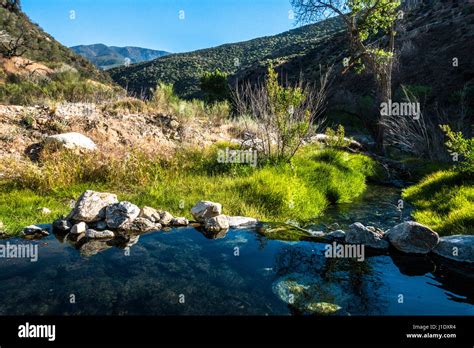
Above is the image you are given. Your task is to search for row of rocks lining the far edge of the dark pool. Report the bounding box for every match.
[12,190,474,264]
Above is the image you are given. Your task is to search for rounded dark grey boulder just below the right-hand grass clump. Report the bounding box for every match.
[386,221,439,254]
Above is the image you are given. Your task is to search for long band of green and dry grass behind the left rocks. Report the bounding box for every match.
[0,143,375,234]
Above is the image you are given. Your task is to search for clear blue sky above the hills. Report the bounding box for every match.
[22,0,295,52]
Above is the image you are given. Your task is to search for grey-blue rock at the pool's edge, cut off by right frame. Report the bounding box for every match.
[433,235,474,263]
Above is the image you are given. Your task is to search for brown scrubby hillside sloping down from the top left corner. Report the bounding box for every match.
[0,2,111,83]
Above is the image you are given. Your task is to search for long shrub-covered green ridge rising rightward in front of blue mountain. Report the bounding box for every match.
[108,18,342,98]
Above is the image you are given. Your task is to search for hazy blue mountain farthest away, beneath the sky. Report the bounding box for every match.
[71,44,170,70]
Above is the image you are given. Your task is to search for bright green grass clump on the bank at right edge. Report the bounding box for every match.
[403,170,474,235]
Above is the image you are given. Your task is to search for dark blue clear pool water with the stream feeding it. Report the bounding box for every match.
[0,188,474,315]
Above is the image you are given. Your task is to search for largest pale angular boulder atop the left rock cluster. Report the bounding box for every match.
[68,190,118,222]
